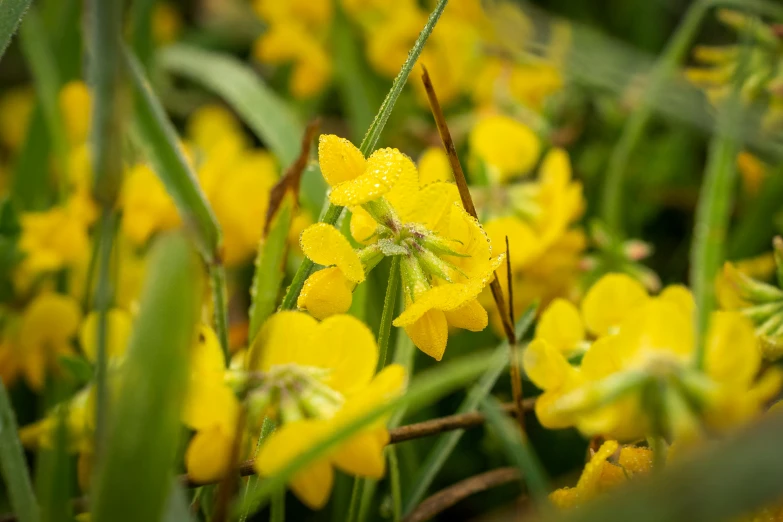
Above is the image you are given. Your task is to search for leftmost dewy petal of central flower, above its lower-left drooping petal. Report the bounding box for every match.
[299,223,364,283]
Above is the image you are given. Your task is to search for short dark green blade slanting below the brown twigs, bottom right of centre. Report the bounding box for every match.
[481,397,550,502]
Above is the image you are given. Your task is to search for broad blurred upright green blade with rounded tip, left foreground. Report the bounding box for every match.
[91,234,203,522]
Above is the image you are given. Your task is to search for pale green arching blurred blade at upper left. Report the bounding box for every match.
[158,44,304,165]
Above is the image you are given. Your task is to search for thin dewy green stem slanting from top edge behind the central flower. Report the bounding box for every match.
[280,0,448,310]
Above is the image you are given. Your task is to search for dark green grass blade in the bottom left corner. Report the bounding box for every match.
[0,380,41,522]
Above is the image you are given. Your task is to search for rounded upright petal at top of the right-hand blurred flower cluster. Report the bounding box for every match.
[582,274,648,335]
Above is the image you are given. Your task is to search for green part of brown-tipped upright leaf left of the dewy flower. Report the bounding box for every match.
[248,196,296,342]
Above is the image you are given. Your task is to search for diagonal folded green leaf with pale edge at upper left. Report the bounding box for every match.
[125,45,220,264]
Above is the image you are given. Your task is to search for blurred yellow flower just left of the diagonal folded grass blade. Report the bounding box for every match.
[121,164,180,246]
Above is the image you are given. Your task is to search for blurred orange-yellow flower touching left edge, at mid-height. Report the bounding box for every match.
[0,293,81,391]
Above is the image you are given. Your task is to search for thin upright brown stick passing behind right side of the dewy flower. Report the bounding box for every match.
[421,65,525,433]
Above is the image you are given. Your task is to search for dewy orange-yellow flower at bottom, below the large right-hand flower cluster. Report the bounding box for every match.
[549,440,652,509]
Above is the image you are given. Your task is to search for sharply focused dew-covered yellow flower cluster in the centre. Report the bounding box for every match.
[298,135,502,360]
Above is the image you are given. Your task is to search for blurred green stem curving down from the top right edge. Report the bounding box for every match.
[602,0,710,234]
